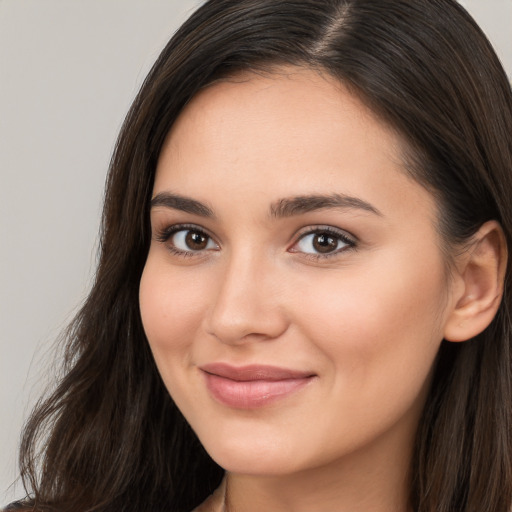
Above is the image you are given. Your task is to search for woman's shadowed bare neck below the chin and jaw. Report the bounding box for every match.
[225,424,413,512]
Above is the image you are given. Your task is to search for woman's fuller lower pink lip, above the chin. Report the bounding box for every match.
[204,373,313,409]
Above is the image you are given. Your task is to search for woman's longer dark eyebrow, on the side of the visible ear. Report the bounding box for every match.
[270,194,383,218]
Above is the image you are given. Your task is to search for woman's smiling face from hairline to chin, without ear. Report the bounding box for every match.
[140,69,450,475]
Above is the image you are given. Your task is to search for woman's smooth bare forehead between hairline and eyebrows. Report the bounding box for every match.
[155,68,433,224]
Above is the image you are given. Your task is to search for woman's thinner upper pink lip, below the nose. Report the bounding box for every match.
[200,363,315,381]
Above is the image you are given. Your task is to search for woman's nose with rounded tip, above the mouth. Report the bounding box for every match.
[205,253,288,345]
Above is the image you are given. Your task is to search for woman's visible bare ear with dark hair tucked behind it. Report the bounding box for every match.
[444,221,507,341]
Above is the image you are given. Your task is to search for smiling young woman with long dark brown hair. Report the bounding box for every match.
[7,0,512,512]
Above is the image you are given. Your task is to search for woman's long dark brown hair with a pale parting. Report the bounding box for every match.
[13,0,512,512]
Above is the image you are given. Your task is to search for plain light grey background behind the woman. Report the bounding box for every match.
[0,0,512,506]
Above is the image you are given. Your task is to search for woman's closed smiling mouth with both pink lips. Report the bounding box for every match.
[200,363,316,409]
